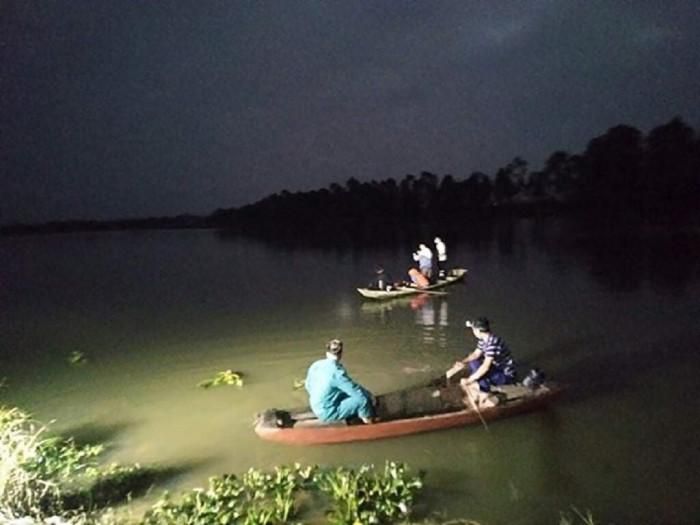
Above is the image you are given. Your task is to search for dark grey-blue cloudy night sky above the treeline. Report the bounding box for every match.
[0,0,700,224]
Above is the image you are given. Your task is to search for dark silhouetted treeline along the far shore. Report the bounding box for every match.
[0,117,700,239]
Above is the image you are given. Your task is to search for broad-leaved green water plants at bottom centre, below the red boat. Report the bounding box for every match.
[143,462,422,525]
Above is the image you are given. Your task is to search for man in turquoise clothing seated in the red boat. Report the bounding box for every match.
[305,339,375,423]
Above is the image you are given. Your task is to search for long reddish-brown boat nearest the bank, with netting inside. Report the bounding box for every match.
[255,374,561,445]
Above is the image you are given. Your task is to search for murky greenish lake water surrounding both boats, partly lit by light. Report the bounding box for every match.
[0,222,700,524]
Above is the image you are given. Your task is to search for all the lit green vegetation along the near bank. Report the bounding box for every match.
[0,406,595,525]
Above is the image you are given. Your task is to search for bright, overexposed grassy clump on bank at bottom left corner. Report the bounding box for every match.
[0,407,167,524]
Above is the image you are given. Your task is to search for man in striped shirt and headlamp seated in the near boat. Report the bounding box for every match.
[446,317,515,395]
